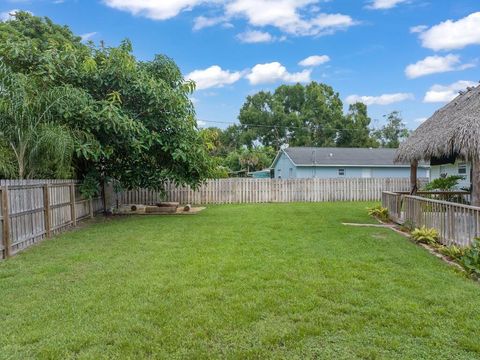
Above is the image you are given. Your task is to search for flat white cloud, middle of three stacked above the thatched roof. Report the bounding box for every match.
[405,54,475,79]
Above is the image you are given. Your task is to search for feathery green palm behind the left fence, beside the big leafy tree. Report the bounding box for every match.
[0,61,75,179]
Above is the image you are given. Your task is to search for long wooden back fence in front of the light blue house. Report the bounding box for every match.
[116,178,420,205]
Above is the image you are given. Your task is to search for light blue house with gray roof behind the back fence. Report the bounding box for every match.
[272,147,430,179]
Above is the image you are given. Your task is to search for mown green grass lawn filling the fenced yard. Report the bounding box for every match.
[0,203,480,359]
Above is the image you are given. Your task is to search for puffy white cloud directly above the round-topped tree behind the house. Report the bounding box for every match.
[246,62,311,85]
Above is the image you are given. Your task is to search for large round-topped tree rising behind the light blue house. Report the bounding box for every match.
[239,82,376,150]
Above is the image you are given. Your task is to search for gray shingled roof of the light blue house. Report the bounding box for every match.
[273,147,425,167]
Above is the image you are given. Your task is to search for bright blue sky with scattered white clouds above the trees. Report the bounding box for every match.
[0,0,480,129]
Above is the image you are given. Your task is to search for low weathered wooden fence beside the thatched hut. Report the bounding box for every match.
[382,192,480,247]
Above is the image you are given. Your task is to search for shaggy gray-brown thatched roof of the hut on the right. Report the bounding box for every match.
[395,86,480,162]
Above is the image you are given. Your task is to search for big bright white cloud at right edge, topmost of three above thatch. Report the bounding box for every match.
[420,12,480,51]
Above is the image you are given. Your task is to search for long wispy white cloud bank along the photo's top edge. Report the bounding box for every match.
[104,0,356,36]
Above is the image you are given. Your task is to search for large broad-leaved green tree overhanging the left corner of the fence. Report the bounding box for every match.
[0,12,212,188]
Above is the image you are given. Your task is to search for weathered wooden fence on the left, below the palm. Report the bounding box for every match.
[0,180,103,259]
